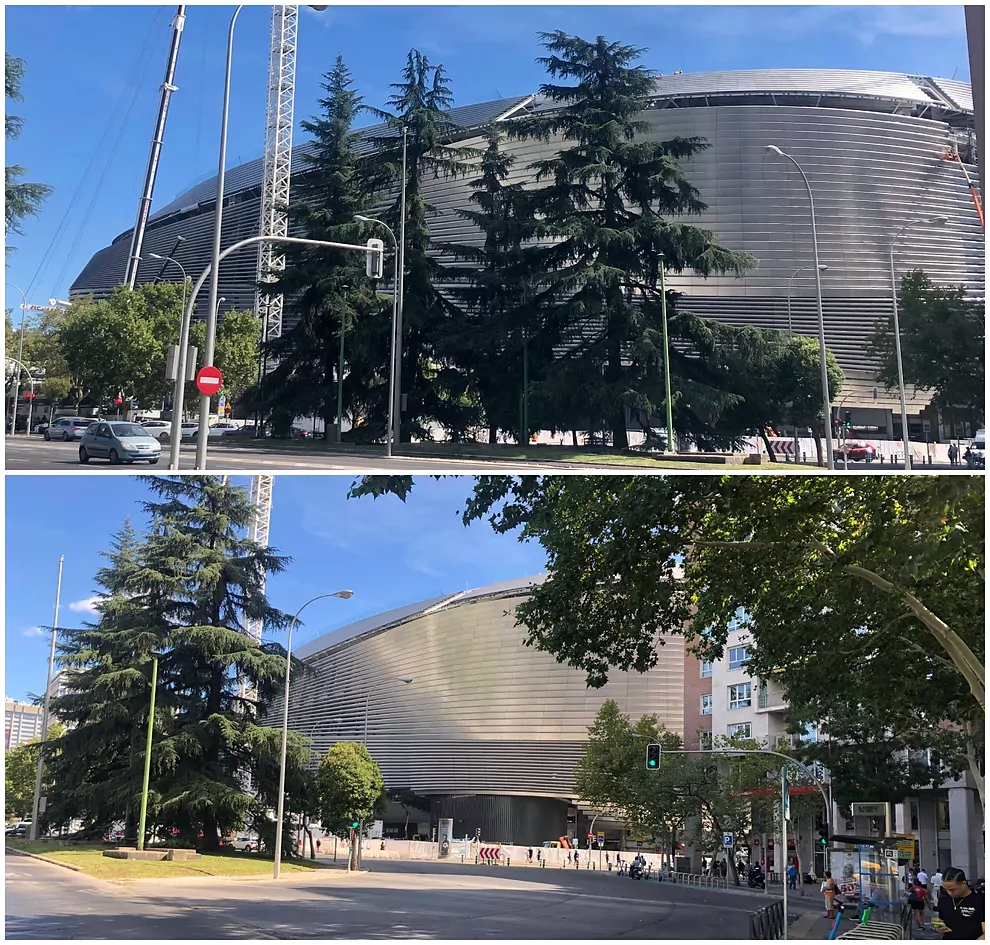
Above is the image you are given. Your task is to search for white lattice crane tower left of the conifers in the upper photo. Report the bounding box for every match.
[255,5,299,350]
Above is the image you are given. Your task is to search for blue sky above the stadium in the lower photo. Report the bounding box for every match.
[5,476,546,699]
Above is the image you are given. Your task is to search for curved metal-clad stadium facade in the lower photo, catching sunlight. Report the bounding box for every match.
[269,589,684,797]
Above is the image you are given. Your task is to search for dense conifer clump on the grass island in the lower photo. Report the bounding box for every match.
[49,476,308,850]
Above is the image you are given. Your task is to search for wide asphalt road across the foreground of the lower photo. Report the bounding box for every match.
[6,857,821,940]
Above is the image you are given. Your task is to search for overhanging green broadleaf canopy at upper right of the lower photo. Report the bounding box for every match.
[353,476,985,800]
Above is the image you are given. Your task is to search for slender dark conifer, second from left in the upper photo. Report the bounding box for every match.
[360,49,479,441]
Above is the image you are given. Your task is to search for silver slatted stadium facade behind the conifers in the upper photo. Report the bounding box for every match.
[71,69,985,438]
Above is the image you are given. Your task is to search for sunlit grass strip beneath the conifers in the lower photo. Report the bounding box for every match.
[6,840,322,880]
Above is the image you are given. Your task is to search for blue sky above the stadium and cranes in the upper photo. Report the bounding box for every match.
[4,5,969,308]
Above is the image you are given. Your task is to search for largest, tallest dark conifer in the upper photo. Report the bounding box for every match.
[510,31,750,448]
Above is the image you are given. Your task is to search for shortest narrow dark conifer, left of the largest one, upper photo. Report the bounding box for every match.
[440,123,553,443]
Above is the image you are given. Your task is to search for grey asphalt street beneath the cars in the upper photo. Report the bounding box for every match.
[5,436,564,474]
